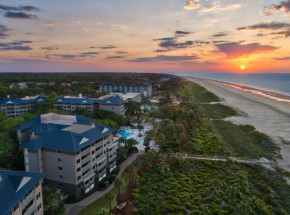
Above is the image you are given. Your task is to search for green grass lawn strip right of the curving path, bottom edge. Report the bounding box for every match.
[80,171,129,215]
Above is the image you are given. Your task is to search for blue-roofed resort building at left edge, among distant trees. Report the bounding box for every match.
[0,96,47,117]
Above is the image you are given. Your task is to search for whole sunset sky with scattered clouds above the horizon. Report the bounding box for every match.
[0,0,290,73]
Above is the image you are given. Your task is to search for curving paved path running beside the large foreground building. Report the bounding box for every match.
[64,151,144,215]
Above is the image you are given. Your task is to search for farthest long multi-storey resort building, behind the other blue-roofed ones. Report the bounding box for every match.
[99,82,152,97]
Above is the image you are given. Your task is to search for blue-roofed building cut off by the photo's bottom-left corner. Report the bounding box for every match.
[0,170,43,215]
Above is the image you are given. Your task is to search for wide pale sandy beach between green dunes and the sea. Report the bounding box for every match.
[185,77,290,172]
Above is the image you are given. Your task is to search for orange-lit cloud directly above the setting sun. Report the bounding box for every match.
[215,42,278,58]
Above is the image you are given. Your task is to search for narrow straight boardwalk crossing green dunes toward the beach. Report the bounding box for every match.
[169,153,275,167]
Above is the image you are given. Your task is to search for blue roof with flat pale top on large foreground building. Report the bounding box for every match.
[15,113,115,153]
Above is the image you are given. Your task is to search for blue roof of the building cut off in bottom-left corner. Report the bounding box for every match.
[0,170,44,214]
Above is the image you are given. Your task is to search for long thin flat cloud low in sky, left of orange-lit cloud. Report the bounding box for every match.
[128,55,199,63]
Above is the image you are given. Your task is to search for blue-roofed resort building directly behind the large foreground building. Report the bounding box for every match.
[54,94,125,115]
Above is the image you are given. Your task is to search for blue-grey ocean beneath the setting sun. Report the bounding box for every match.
[176,73,290,96]
